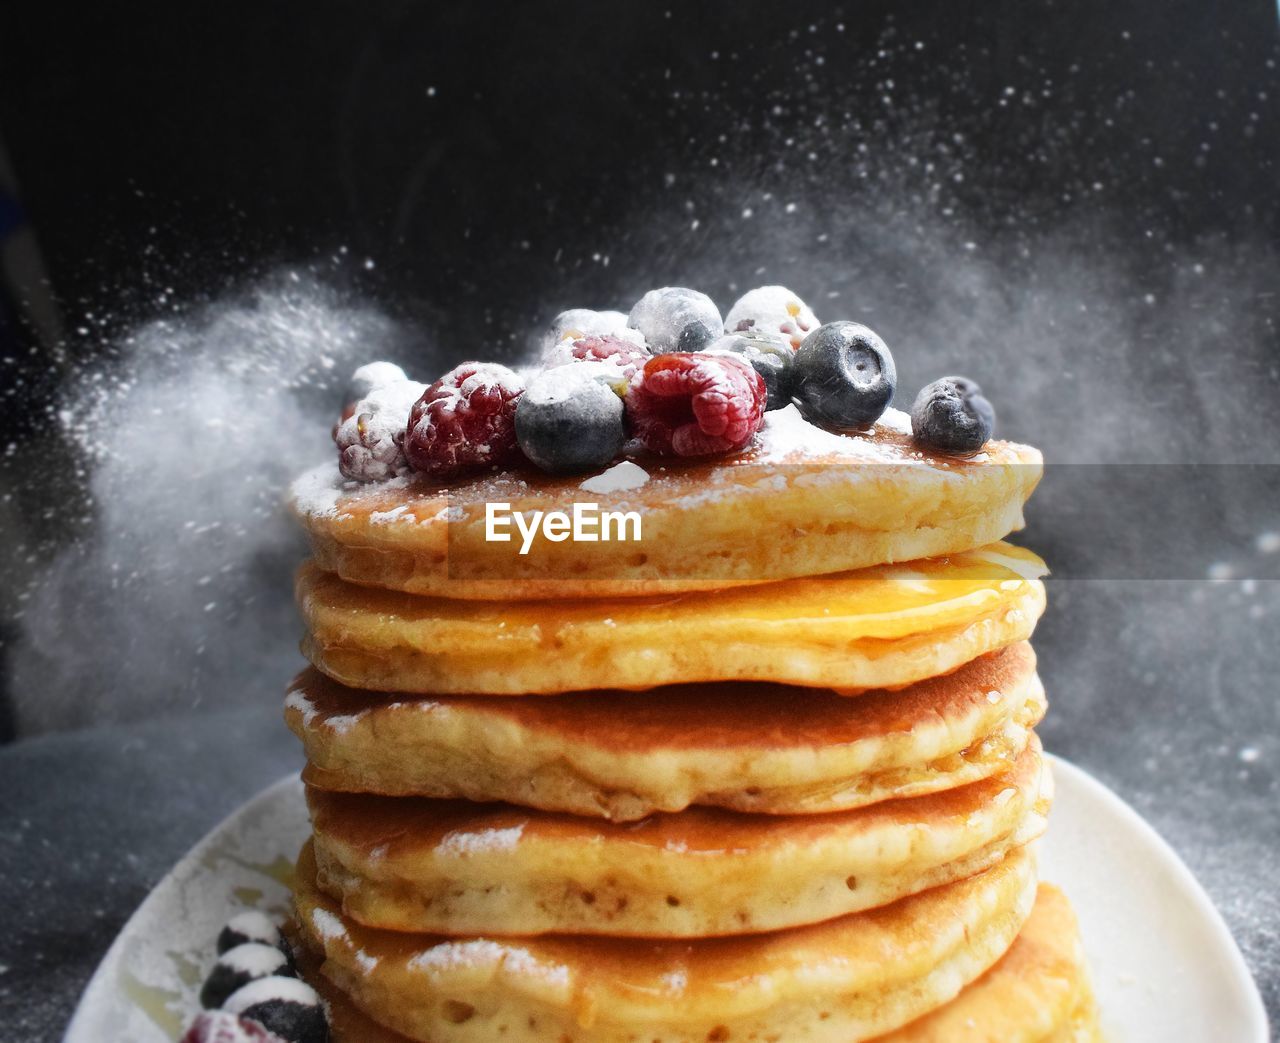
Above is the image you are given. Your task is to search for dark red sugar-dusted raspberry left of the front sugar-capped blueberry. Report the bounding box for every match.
[404,362,525,480]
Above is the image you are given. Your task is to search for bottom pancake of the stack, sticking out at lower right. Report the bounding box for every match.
[293,884,1102,1043]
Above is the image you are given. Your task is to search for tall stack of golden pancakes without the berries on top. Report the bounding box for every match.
[287,410,1097,1043]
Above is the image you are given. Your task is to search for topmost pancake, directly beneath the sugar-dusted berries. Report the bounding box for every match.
[292,407,1043,600]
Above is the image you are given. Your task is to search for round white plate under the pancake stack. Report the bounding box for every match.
[64,758,1268,1043]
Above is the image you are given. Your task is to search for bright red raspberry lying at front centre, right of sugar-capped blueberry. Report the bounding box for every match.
[625,352,768,457]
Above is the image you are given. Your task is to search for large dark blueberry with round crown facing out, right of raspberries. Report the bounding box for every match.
[791,321,897,430]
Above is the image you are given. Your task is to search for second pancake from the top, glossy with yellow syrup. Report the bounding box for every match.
[297,544,1044,695]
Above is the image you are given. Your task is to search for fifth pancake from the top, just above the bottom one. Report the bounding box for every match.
[296,847,1036,1043]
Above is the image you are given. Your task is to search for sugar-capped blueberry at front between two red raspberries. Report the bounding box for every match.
[516,360,624,475]
